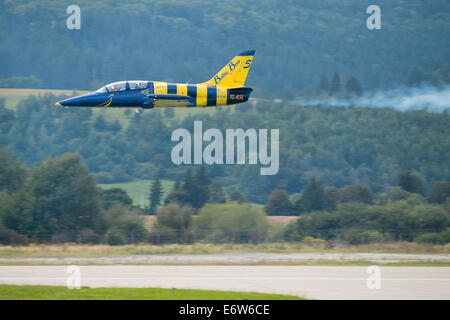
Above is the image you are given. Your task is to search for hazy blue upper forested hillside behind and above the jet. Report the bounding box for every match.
[0,0,450,96]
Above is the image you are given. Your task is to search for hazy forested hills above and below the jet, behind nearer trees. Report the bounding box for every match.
[0,0,450,203]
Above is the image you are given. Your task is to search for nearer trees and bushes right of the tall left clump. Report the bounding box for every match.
[146,167,450,244]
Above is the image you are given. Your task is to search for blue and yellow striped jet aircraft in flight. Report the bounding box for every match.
[56,50,255,109]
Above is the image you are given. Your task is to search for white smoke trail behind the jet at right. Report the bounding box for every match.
[294,85,450,112]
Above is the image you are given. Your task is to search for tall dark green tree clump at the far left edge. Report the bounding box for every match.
[0,148,148,244]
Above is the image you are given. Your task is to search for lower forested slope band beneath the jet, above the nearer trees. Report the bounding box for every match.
[0,95,450,203]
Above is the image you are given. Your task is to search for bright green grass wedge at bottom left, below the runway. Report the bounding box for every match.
[0,285,303,300]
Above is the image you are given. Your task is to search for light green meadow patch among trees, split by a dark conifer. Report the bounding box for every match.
[100,180,174,207]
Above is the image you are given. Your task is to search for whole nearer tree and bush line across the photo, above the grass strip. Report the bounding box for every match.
[0,148,450,245]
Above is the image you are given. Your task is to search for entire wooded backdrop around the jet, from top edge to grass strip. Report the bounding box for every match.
[0,0,450,248]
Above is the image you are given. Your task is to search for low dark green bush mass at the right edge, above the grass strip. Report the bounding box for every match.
[285,198,450,243]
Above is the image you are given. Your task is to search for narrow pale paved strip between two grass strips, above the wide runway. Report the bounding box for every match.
[0,252,450,266]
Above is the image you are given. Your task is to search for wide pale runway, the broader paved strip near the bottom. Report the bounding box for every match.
[0,265,450,300]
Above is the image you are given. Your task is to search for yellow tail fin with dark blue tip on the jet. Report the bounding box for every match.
[200,50,255,88]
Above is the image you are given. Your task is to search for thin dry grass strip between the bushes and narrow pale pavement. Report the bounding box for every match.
[0,242,450,263]
